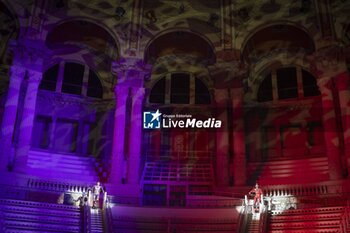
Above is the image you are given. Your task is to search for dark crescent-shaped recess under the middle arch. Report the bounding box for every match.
[144,28,216,64]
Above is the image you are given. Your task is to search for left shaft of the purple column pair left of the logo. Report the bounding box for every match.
[109,86,129,186]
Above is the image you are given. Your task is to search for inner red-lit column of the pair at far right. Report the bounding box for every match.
[318,78,342,180]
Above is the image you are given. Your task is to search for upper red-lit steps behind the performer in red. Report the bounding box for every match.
[247,157,329,185]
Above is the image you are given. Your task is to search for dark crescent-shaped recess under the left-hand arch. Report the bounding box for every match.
[45,17,120,59]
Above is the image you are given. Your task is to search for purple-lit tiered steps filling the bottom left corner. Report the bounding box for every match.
[0,199,81,233]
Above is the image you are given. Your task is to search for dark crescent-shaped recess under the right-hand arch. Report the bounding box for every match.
[241,22,315,62]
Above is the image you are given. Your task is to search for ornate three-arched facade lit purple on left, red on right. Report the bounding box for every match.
[0,0,350,232]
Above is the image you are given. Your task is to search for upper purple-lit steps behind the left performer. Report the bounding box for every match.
[27,151,99,183]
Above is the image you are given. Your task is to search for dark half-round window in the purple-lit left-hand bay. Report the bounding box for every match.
[39,62,103,98]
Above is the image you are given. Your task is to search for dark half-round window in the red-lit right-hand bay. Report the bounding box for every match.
[257,67,320,102]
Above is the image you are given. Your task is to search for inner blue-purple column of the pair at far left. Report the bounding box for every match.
[14,70,42,171]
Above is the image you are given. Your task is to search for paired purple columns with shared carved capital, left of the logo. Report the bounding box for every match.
[110,57,151,198]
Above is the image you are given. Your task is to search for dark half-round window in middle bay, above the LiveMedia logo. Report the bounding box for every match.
[149,73,210,104]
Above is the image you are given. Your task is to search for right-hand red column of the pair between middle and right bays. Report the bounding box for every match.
[231,88,247,186]
